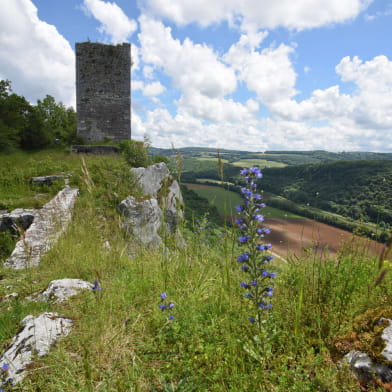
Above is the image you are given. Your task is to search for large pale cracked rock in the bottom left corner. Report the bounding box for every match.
[0,313,72,386]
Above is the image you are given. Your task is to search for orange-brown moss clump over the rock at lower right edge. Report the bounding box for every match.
[331,305,392,365]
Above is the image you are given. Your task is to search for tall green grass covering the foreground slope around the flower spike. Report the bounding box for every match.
[0,151,392,392]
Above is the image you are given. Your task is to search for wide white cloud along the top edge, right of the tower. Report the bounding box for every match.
[145,0,372,30]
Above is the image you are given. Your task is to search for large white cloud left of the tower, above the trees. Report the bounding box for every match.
[0,0,75,105]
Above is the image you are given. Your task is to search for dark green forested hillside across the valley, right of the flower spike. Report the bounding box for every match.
[263,160,392,227]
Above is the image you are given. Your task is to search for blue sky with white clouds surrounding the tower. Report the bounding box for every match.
[0,0,392,152]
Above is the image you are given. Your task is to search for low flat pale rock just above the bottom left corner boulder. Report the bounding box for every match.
[28,279,93,303]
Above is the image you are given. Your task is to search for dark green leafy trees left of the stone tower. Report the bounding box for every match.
[0,80,81,152]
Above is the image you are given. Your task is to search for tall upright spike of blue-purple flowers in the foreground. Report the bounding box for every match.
[235,167,276,324]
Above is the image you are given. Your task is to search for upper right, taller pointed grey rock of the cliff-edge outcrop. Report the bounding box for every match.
[131,162,184,234]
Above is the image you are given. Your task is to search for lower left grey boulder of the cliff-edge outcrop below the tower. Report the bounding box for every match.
[118,196,162,247]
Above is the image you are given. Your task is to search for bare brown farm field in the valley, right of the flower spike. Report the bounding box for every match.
[265,218,383,259]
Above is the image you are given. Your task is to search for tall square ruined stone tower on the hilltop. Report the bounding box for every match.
[75,42,131,142]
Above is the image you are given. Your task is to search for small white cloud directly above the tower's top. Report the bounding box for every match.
[84,0,137,44]
